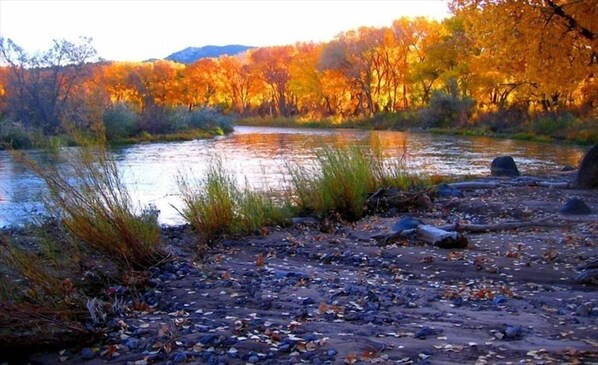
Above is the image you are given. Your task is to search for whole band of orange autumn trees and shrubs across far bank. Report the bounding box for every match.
[0,0,598,146]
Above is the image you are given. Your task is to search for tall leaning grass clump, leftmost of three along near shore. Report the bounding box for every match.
[15,144,165,270]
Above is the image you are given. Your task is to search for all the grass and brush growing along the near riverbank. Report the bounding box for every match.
[0,137,432,350]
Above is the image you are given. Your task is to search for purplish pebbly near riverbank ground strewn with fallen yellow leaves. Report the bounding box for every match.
[2,169,598,364]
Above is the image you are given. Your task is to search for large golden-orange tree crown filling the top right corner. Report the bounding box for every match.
[451,0,598,110]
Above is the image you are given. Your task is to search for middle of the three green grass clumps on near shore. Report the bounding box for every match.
[179,159,290,242]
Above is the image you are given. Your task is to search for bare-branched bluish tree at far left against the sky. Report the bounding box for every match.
[0,38,97,133]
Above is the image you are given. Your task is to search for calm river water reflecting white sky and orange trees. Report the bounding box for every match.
[0,127,584,227]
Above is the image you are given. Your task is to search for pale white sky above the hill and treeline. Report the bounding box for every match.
[0,0,449,61]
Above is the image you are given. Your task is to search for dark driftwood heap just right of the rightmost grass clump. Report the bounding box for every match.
[365,188,434,212]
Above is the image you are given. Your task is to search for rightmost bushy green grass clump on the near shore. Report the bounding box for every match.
[288,146,425,221]
